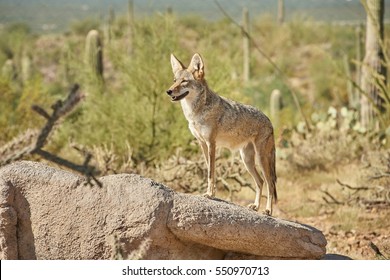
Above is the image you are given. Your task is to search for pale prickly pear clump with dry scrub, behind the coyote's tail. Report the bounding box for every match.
[279,107,378,170]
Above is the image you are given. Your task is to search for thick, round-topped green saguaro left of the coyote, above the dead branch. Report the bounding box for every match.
[85,30,103,81]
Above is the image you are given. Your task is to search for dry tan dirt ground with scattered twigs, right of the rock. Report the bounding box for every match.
[263,156,390,260]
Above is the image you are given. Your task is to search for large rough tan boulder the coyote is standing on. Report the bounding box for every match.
[0,161,326,259]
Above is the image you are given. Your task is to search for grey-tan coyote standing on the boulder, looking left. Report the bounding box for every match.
[167,53,277,215]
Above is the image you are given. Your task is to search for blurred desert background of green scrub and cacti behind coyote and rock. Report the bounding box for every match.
[0,0,390,259]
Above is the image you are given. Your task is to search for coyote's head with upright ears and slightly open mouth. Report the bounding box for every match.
[167,53,204,101]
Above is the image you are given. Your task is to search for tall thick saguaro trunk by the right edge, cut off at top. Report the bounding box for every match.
[360,0,386,128]
